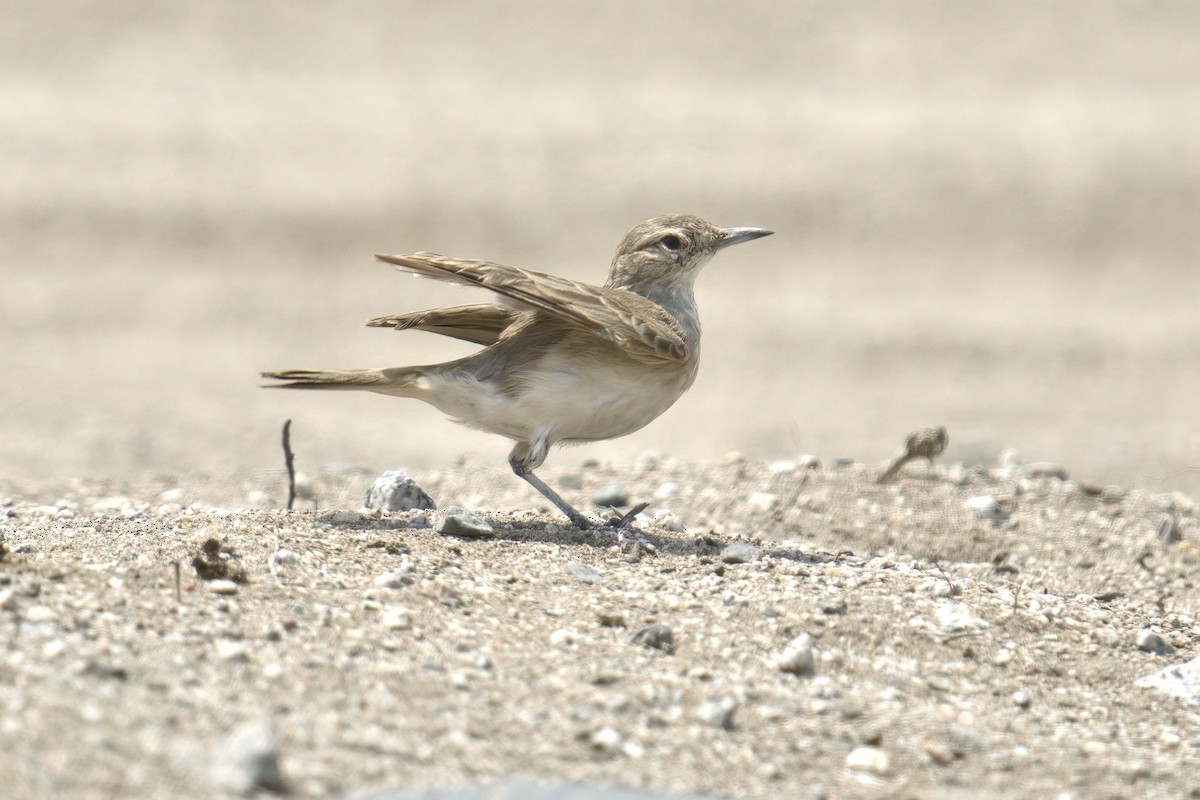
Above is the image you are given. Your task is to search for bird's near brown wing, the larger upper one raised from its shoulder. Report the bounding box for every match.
[376,253,689,363]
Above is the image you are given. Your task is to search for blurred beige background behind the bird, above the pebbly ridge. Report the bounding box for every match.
[0,0,1200,495]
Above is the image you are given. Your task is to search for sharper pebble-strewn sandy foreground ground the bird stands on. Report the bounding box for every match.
[0,458,1200,799]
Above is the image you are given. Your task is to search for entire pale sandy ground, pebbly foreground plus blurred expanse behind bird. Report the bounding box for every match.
[0,0,1200,796]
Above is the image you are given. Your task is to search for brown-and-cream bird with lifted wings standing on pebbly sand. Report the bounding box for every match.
[260,213,774,529]
